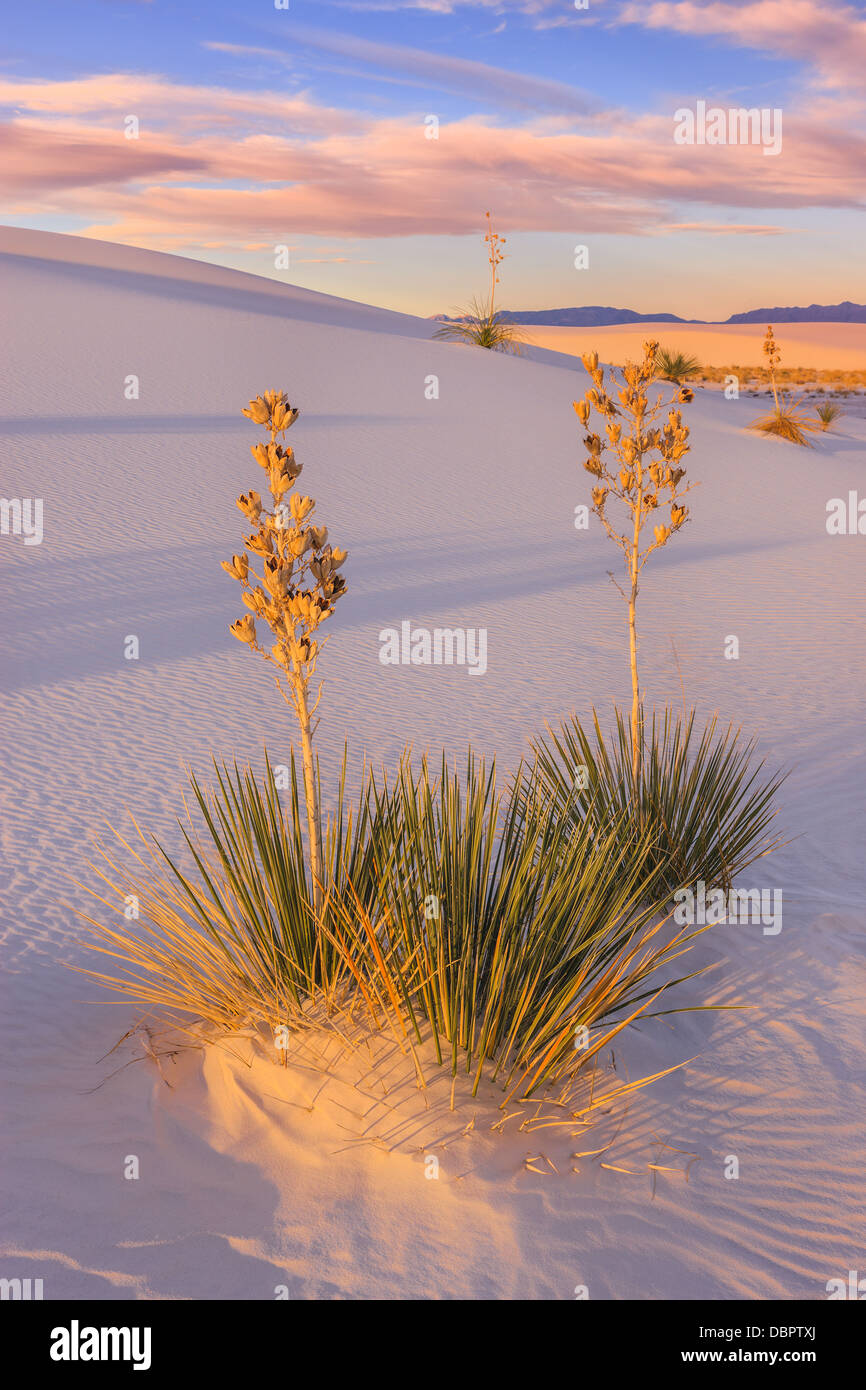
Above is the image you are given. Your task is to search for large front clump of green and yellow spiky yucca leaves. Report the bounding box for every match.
[79,755,698,1113]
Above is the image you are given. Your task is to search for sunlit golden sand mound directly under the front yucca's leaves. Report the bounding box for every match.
[166,1030,639,1182]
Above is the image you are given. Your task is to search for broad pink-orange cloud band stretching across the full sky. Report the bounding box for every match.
[0,76,866,249]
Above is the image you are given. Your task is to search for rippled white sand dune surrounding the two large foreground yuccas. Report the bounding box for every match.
[0,229,866,1300]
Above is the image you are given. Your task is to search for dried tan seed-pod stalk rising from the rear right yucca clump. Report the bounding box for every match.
[574,342,695,787]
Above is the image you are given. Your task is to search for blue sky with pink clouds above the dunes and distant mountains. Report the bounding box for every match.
[0,0,866,320]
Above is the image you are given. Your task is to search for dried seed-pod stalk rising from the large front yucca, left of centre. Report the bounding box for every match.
[222,391,346,910]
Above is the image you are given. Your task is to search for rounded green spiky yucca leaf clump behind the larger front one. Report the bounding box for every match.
[534,710,784,894]
